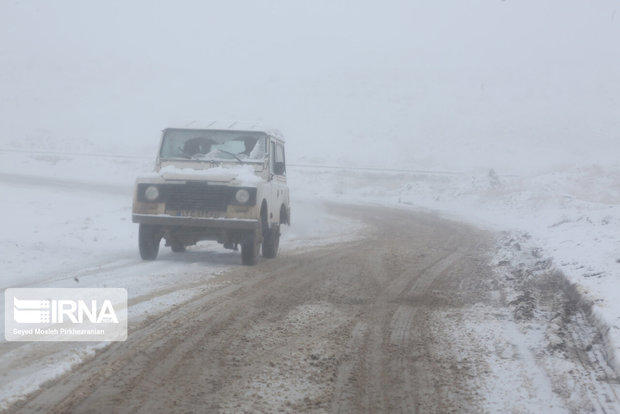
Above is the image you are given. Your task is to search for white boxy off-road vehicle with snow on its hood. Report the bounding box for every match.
[132,124,291,265]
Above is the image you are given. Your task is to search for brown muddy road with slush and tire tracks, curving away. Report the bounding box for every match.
[4,207,620,413]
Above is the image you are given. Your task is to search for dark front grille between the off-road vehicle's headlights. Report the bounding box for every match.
[166,183,228,213]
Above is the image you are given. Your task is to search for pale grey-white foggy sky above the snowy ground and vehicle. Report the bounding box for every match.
[0,0,620,171]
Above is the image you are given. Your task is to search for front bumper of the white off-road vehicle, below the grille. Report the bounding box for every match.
[132,214,259,230]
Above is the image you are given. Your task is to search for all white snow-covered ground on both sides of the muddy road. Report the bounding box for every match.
[0,148,620,409]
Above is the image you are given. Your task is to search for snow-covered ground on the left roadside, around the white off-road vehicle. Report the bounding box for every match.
[0,150,361,410]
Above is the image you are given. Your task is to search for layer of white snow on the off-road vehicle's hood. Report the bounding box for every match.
[158,165,262,185]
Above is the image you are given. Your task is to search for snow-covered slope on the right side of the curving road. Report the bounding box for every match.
[290,166,620,371]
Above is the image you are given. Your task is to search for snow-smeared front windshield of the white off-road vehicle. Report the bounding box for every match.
[160,129,266,162]
